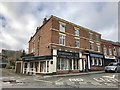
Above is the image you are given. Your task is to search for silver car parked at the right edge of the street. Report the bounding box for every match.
[105,62,120,72]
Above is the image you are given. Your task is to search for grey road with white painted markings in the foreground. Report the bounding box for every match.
[0,69,120,88]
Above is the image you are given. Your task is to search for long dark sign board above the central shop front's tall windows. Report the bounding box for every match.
[57,51,79,58]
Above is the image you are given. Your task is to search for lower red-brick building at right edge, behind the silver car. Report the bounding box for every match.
[101,39,120,66]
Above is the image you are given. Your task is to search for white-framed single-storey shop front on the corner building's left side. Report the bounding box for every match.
[23,56,52,75]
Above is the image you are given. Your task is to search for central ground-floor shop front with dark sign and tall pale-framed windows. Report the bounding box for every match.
[57,50,80,73]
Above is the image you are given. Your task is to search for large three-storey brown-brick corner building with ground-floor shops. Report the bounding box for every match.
[16,16,119,74]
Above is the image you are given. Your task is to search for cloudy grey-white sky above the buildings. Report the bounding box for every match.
[0,2,118,51]
